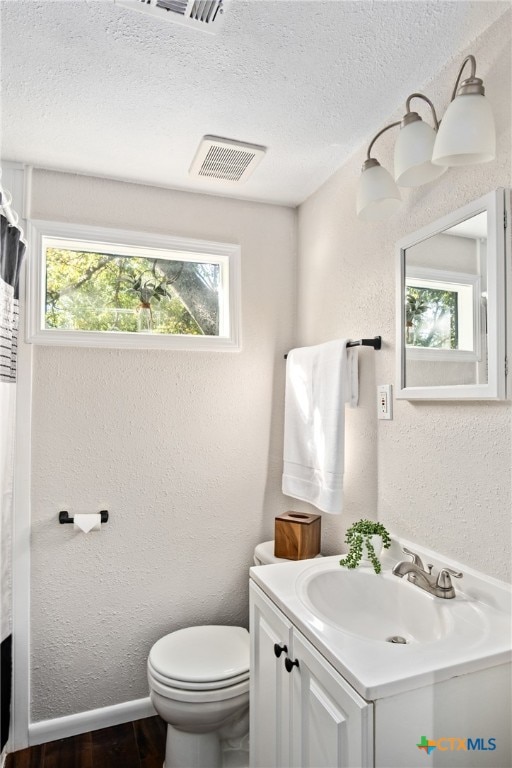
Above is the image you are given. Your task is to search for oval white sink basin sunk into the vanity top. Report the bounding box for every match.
[297,567,454,643]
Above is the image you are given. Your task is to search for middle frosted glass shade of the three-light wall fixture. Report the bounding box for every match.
[395,120,447,187]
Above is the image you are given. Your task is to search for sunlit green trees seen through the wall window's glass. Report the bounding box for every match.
[45,247,220,336]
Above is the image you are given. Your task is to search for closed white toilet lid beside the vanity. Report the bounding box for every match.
[149,626,249,683]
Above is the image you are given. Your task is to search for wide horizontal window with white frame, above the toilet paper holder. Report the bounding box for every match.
[24,221,239,350]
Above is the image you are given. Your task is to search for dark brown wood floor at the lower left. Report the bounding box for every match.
[5,717,166,768]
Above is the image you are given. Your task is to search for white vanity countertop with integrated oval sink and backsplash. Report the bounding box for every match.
[251,540,512,701]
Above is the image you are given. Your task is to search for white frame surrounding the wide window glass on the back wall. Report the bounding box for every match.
[26,219,241,352]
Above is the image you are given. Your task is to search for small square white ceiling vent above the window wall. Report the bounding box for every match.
[189,136,266,183]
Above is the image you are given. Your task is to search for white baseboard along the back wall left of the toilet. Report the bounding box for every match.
[28,696,156,747]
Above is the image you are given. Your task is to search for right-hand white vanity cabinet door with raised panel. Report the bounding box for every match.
[290,630,373,768]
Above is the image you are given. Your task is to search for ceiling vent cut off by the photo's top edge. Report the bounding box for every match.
[114,0,226,33]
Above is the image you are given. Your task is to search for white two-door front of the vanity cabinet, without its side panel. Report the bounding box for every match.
[250,584,373,768]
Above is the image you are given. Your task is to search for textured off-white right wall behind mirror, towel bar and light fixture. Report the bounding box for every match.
[298,12,512,579]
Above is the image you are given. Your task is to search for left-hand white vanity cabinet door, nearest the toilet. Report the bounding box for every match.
[250,584,292,768]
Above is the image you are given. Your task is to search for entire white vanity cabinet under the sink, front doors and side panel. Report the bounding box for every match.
[250,584,512,768]
